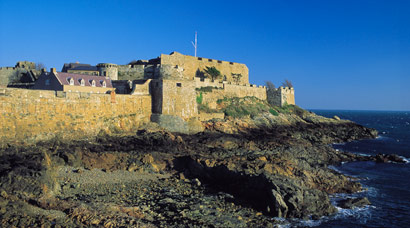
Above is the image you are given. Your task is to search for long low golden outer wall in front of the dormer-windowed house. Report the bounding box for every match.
[0,88,151,142]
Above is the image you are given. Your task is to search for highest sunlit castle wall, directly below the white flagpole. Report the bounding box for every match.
[160,52,249,84]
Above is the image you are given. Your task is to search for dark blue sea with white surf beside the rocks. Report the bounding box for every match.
[308,110,410,227]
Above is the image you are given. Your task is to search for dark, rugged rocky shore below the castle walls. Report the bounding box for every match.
[0,111,400,227]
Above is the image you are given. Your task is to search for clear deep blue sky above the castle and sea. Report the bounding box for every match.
[0,0,410,110]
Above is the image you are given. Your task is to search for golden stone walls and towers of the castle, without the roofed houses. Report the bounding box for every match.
[0,52,295,141]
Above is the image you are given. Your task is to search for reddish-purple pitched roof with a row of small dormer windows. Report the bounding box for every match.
[51,72,112,88]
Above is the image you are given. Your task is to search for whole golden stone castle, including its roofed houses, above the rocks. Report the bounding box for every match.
[0,52,295,138]
